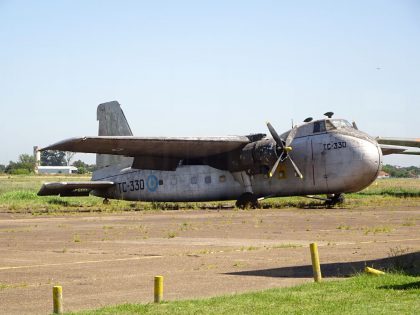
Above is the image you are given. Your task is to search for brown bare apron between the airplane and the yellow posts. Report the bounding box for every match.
[0,205,420,314]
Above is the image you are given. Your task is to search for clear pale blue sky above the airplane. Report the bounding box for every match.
[0,0,420,166]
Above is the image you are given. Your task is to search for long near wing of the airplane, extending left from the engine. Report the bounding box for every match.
[41,136,250,159]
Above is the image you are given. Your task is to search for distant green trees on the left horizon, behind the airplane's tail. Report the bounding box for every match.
[0,151,96,175]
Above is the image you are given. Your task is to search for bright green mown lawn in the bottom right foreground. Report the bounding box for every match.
[68,274,420,315]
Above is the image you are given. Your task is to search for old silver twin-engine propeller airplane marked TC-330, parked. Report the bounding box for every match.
[38,101,420,208]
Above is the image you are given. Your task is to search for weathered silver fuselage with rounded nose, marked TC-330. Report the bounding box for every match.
[92,126,382,201]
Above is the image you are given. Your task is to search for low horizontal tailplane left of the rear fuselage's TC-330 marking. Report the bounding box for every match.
[38,181,115,197]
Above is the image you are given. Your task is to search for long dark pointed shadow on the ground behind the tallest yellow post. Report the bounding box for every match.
[226,252,420,278]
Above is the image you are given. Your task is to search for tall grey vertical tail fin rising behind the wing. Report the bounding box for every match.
[96,101,133,168]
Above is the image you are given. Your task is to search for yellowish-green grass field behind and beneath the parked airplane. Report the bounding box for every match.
[0,175,420,212]
